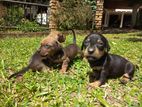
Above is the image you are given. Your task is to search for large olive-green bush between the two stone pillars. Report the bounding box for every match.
[57,0,93,29]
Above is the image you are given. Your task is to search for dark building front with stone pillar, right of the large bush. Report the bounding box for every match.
[95,0,142,29]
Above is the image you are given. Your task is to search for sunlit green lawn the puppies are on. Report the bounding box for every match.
[0,33,142,107]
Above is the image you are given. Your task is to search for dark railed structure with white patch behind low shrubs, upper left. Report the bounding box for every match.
[0,0,49,25]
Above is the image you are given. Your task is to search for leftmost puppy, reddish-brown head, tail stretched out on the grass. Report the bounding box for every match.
[8,36,61,79]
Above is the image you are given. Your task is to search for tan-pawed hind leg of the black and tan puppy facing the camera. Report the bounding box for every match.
[120,62,135,84]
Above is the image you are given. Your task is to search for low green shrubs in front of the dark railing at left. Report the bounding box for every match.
[0,6,45,32]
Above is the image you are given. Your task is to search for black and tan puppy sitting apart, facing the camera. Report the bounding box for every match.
[82,33,134,87]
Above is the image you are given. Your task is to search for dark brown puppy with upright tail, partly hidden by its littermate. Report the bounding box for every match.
[53,30,81,74]
